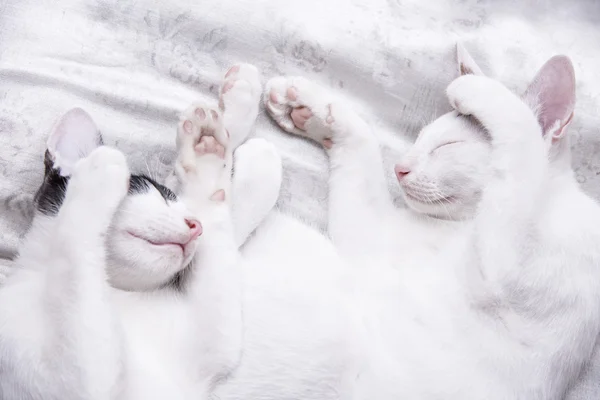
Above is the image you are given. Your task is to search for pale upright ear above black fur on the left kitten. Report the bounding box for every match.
[47,108,102,176]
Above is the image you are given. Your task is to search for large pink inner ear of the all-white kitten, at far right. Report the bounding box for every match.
[524,56,576,141]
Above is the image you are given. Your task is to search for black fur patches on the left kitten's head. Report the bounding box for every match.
[34,151,177,215]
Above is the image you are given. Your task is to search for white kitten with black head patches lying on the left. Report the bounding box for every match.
[0,65,281,400]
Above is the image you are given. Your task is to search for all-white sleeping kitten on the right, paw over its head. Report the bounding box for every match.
[216,48,600,400]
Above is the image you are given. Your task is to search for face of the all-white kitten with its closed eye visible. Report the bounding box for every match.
[396,112,490,219]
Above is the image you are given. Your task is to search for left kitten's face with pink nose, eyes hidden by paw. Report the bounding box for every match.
[106,175,202,291]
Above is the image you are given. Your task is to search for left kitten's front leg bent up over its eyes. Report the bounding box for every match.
[49,147,129,399]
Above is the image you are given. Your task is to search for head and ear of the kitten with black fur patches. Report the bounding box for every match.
[35,109,202,291]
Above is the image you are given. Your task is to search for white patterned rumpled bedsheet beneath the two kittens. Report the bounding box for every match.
[0,0,600,399]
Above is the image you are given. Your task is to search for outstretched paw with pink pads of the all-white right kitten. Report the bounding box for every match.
[264,76,336,148]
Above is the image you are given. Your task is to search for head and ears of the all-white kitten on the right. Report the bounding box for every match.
[395,45,575,219]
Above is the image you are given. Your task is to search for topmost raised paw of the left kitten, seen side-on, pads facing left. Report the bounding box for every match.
[219,64,262,148]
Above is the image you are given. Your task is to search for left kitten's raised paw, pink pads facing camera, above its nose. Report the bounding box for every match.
[175,104,231,200]
